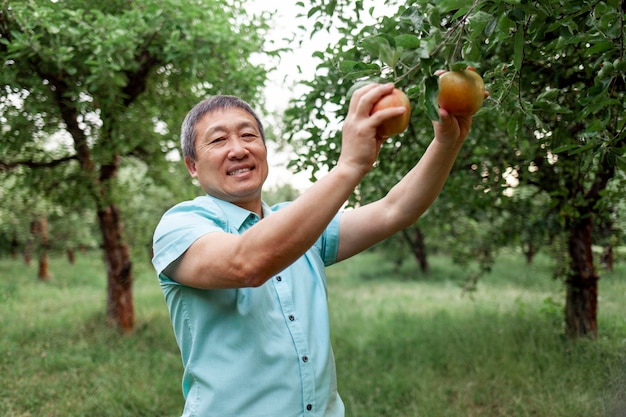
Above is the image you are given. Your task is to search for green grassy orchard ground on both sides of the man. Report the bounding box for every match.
[0,249,626,417]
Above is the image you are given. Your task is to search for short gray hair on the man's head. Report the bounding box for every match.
[180,95,265,161]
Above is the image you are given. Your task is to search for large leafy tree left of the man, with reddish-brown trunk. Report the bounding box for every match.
[0,0,267,331]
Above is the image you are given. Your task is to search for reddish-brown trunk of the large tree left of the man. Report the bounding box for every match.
[98,204,135,332]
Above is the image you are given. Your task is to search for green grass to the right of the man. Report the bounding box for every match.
[331,250,626,417]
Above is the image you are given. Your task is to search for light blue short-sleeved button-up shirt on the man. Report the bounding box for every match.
[152,196,344,417]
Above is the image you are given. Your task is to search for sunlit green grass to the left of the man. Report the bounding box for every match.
[0,253,182,417]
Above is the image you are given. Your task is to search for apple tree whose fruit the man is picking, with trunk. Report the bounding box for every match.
[286,0,626,338]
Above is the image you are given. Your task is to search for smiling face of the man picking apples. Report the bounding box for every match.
[185,107,268,211]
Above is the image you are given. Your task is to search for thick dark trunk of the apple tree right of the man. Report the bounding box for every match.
[565,215,599,339]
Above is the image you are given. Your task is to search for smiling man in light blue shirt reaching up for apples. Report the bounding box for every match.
[153,84,471,417]
